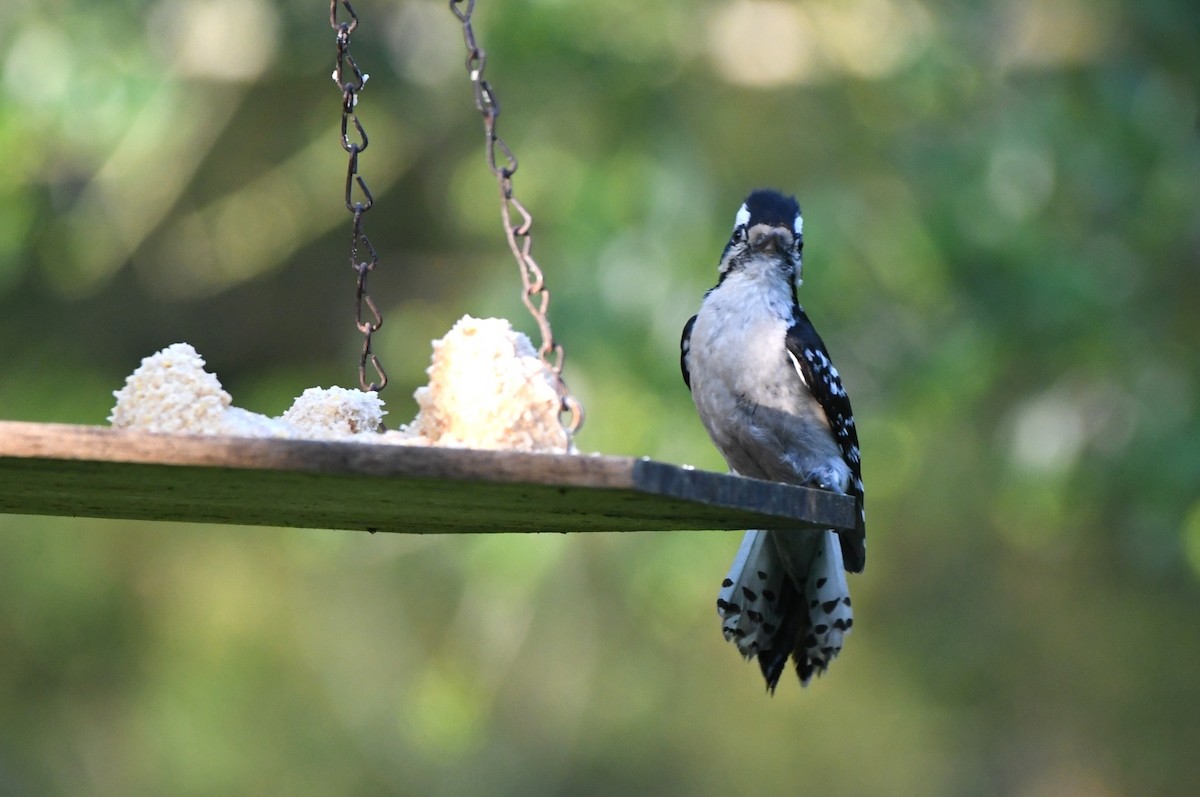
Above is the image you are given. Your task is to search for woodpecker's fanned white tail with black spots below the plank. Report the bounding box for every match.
[716,529,854,691]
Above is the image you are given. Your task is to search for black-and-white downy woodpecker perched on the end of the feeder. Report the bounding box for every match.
[680,191,866,691]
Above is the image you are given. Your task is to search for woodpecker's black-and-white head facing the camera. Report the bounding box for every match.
[718,190,804,283]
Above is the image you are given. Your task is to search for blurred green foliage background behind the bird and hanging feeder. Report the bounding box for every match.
[0,0,1200,797]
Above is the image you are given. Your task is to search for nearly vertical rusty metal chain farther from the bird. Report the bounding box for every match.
[329,0,388,392]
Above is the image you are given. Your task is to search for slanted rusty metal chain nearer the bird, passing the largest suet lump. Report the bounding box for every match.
[450,0,583,436]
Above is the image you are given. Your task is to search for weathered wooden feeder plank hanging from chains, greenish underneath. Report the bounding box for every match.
[0,421,856,533]
